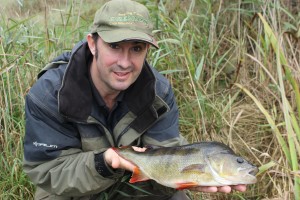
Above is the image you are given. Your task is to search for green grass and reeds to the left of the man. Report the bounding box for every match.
[0,1,99,199]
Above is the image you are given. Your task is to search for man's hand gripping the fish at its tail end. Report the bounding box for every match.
[104,147,146,172]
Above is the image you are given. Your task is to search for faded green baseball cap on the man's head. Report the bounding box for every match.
[91,0,158,48]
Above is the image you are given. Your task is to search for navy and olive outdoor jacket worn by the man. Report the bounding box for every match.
[24,42,185,199]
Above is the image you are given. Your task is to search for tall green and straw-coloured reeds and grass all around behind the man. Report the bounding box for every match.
[0,0,300,200]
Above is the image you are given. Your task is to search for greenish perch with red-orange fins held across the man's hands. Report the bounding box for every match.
[113,142,258,189]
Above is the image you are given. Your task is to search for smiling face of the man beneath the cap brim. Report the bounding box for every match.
[91,38,149,95]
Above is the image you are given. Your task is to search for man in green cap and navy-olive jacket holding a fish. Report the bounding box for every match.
[24,0,245,200]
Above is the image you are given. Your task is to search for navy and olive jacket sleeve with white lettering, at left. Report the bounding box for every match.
[24,81,123,196]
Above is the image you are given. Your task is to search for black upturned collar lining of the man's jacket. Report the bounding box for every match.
[58,42,156,122]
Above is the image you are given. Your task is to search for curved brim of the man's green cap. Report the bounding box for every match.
[97,29,159,49]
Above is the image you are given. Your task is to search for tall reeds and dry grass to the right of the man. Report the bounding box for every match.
[154,0,300,199]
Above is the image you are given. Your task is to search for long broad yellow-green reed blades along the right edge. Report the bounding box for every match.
[237,9,300,199]
